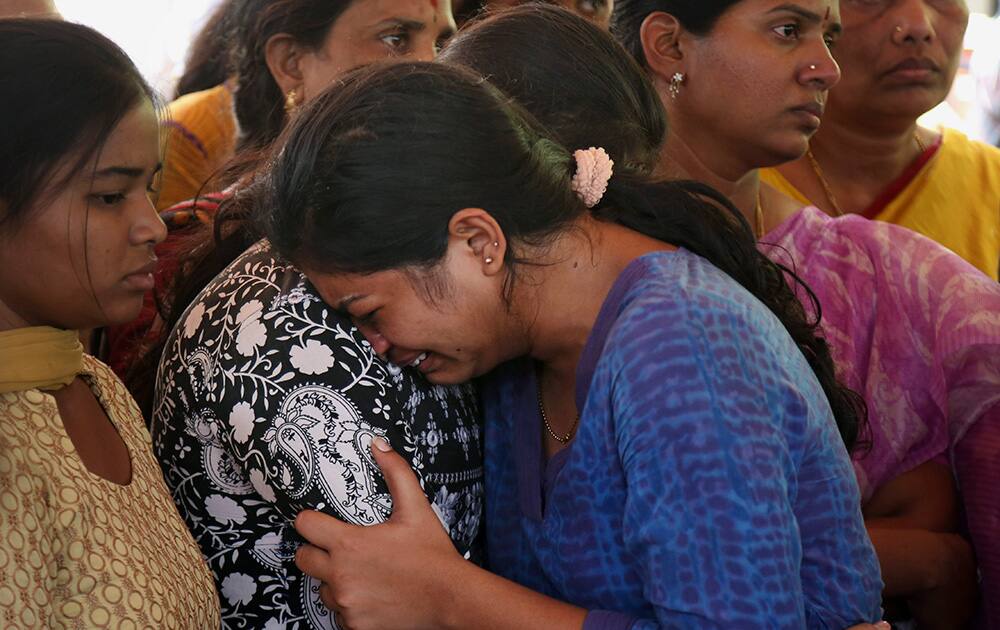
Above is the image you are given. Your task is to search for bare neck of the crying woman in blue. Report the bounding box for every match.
[515,217,670,378]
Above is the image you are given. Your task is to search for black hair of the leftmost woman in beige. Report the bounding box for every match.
[0,18,157,229]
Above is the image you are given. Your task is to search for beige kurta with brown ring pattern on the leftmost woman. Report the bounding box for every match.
[0,356,220,629]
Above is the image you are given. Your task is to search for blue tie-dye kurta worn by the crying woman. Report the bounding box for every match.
[484,250,882,630]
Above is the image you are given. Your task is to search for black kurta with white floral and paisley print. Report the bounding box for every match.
[152,241,483,630]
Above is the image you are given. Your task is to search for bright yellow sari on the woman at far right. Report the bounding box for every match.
[760,129,1000,280]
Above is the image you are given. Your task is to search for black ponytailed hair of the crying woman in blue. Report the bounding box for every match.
[257,58,864,448]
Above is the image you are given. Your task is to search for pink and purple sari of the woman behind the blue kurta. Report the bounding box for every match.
[761,207,1000,625]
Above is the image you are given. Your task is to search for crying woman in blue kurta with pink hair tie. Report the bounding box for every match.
[234,56,881,628]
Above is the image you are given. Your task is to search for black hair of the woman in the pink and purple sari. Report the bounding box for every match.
[611,0,740,67]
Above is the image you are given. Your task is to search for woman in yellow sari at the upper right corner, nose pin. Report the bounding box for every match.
[761,0,1000,279]
